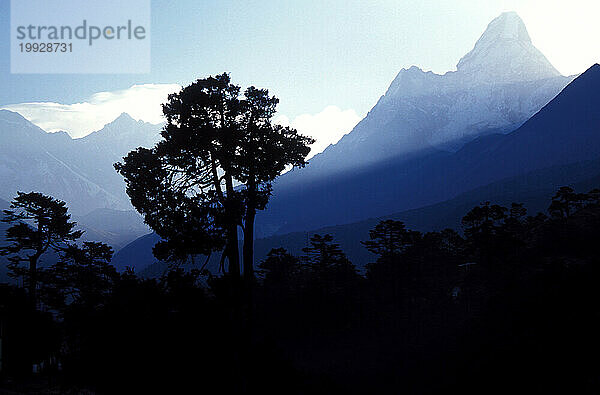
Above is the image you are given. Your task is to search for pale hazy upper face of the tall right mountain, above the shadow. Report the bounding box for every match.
[277,12,574,183]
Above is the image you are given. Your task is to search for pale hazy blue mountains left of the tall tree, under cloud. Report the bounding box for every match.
[0,110,162,216]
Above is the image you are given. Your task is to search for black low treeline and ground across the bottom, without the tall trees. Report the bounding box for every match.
[0,188,600,393]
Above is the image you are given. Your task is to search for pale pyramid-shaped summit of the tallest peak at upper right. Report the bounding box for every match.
[457,12,560,82]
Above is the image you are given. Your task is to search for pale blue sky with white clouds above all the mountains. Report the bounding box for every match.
[0,0,600,154]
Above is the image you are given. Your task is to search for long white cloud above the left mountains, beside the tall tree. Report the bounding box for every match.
[3,84,181,137]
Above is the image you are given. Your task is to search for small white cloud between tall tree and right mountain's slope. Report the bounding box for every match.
[275,106,361,158]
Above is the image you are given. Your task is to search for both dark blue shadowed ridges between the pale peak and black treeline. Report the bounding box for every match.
[115,65,600,274]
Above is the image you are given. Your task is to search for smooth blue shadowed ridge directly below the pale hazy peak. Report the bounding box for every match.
[257,65,600,235]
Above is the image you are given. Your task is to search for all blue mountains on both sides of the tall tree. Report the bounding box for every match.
[0,13,600,278]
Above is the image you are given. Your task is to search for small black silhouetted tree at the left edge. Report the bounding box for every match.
[0,192,83,304]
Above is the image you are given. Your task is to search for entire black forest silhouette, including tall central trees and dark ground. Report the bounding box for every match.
[0,74,600,394]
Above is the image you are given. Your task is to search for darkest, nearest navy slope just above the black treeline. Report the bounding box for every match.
[114,160,600,276]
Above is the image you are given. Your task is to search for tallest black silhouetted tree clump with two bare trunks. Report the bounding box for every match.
[115,74,313,278]
